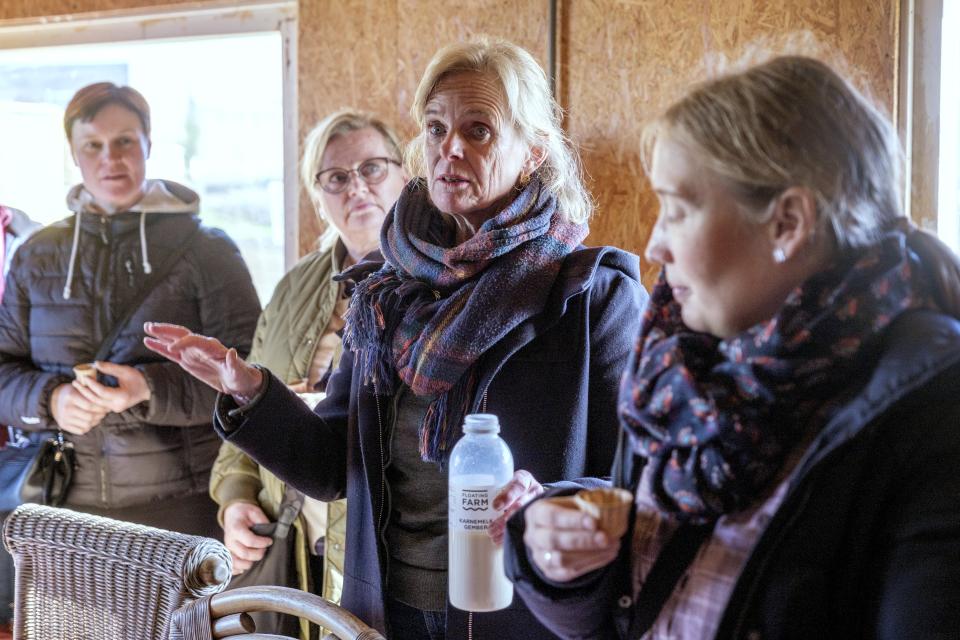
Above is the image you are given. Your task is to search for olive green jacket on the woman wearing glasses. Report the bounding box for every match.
[210,242,347,638]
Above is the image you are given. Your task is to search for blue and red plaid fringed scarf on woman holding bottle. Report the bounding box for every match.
[344,178,587,462]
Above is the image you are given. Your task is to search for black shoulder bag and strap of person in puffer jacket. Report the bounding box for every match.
[0,224,200,512]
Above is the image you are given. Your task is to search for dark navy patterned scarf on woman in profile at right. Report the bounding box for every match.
[619,231,935,522]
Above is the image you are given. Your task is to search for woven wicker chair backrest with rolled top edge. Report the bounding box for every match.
[3,504,231,640]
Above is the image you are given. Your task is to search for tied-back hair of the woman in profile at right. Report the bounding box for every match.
[642,56,960,317]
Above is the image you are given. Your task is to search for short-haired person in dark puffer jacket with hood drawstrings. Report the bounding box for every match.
[0,83,260,536]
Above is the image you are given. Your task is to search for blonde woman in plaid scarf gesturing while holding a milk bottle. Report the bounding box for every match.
[147,39,646,640]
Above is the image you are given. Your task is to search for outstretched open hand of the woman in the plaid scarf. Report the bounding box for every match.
[143,322,263,399]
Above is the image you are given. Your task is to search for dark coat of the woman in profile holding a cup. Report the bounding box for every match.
[506,311,960,640]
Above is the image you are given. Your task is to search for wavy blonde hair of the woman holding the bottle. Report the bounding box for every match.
[406,36,594,223]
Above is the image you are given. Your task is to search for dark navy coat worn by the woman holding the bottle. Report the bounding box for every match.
[216,242,647,640]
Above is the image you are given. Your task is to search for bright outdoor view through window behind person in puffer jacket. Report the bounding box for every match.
[0,32,284,303]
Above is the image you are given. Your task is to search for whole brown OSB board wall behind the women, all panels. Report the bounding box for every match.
[0,0,899,282]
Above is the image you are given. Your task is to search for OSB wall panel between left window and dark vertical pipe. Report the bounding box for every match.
[297,0,547,253]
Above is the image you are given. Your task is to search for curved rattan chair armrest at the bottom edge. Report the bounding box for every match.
[170,586,384,640]
